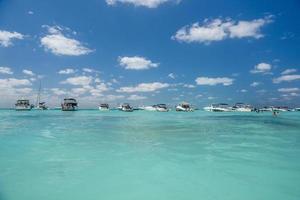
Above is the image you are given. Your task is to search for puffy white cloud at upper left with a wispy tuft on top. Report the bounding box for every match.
[41,26,92,56]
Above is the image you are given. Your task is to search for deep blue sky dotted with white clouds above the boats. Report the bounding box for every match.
[0,0,300,108]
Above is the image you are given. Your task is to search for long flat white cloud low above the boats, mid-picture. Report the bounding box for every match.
[117,82,169,93]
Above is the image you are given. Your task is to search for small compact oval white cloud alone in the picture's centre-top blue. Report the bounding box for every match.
[119,56,159,70]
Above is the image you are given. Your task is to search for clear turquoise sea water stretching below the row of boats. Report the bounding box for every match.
[0,110,300,200]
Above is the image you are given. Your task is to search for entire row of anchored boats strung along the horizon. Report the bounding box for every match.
[15,98,300,112]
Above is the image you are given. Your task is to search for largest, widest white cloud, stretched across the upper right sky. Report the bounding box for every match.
[172,16,272,44]
